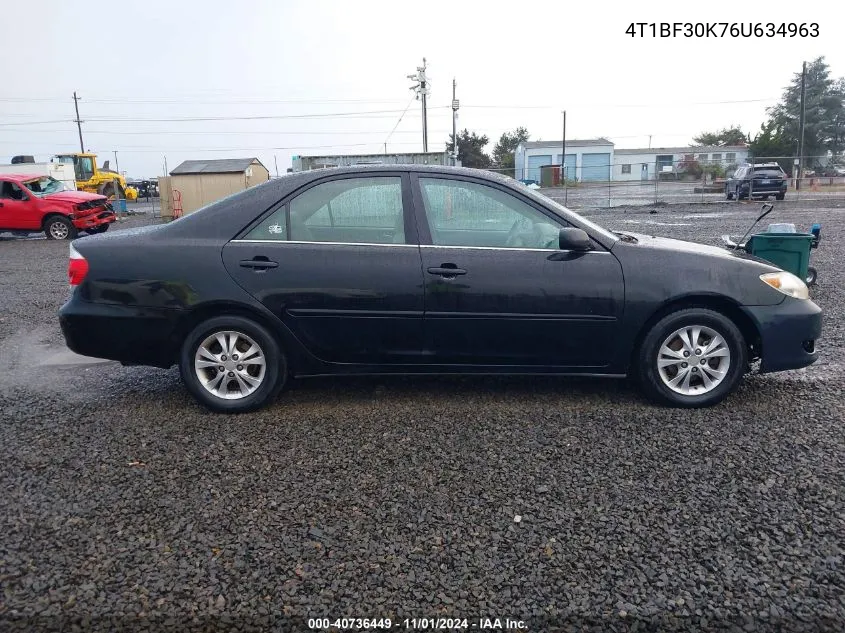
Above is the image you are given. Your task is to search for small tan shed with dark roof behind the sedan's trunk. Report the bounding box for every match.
[159,158,270,217]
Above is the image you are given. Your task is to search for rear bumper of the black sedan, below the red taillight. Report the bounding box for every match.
[59,292,184,368]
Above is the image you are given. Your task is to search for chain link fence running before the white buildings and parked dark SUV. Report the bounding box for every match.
[489,155,845,209]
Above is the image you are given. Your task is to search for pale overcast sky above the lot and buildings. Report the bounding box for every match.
[0,0,845,178]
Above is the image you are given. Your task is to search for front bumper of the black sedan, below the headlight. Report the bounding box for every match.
[743,297,822,373]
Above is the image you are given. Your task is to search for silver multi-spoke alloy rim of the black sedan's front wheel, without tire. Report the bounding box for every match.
[657,325,731,396]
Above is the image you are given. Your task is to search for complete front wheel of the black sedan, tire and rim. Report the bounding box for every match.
[635,308,748,408]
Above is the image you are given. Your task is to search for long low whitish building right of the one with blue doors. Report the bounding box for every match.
[612,145,748,180]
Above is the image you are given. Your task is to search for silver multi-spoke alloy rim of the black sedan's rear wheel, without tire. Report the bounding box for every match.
[194,330,267,400]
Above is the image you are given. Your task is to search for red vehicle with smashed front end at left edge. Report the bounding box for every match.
[0,174,116,240]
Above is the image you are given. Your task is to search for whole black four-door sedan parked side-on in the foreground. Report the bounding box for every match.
[60,165,821,412]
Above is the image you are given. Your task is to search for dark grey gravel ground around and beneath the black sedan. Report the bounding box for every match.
[0,205,845,631]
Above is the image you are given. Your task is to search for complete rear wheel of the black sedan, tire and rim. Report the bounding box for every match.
[179,316,287,413]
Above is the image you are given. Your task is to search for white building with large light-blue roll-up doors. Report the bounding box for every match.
[514,138,613,182]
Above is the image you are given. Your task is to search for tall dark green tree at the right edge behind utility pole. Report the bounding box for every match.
[768,57,845,166]
